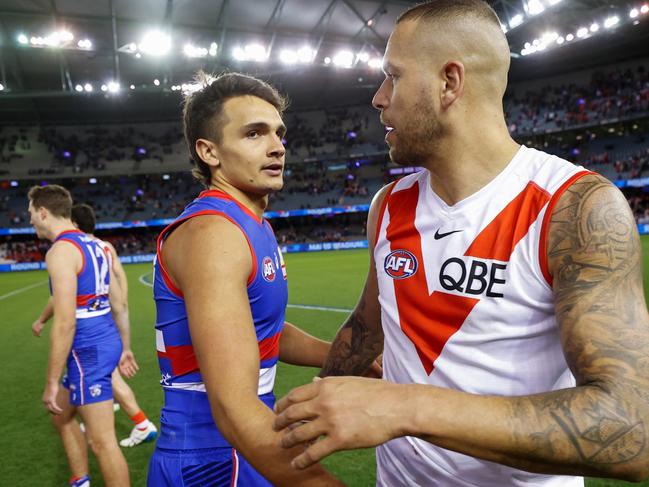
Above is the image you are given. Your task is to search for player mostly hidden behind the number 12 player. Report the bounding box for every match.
[32,203,158,447]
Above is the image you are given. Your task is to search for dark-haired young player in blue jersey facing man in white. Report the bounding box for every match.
[148,73,340,487]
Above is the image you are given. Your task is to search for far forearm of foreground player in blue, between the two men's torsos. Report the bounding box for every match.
[279,321,331,367]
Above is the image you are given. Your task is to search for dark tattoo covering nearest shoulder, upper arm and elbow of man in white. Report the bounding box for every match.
[512,175,649,476]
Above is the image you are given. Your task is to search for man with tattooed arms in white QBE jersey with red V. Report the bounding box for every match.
[276,0,649,487]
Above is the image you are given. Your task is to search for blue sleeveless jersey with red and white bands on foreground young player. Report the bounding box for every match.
[153,190,288,454]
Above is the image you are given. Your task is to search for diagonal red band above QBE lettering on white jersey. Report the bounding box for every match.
[464,181,550,262]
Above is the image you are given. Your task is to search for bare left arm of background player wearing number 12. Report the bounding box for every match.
[43,241,81,413]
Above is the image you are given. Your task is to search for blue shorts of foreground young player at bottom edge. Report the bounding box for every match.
[146,448,273,487]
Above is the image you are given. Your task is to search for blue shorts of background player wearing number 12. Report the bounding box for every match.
[63,340,122,406]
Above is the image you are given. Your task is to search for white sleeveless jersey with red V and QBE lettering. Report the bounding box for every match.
[374,147,588,487]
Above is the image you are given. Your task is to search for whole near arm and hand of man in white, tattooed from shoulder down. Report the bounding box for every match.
[276,176,649,480]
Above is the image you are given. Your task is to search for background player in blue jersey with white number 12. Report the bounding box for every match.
[28,185,136,486]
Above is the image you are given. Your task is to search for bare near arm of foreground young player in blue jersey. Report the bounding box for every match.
[162,216,340,486]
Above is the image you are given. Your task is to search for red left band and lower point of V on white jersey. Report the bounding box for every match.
[386,184,479,375]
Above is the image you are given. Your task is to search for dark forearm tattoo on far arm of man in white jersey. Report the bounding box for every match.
[319,295,383,377]
